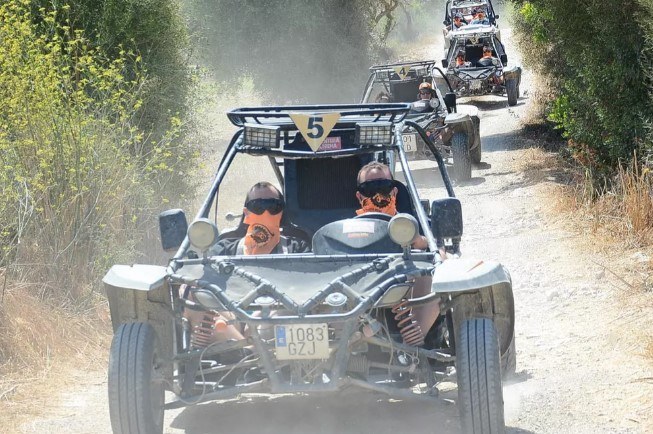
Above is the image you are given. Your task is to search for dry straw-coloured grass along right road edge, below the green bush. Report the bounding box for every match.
[515,148,653,372]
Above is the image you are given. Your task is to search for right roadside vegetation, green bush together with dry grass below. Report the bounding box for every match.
[513,0,653,262]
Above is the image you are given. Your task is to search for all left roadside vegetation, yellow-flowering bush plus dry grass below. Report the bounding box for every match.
[0,0,196,380]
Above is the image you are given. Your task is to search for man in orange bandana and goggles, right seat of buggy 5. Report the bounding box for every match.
[356,161,440,336]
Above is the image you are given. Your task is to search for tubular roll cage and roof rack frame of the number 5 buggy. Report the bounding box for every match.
[172,103,455,268]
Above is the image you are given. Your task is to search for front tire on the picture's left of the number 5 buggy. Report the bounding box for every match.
[108,322,164,434]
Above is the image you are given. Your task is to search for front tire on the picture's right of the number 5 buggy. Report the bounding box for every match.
[456,318,505,434]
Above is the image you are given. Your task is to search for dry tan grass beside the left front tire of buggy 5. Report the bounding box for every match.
[0,274,111,426]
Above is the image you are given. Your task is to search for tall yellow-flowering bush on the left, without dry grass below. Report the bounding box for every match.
[0,0,192,302]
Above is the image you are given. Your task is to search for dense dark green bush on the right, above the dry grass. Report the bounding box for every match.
[516,0,653,174]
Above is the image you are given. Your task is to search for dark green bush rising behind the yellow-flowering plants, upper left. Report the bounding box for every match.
[31,0,192,140]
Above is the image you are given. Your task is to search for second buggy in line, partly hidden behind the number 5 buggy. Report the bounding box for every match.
[360,60,481,181]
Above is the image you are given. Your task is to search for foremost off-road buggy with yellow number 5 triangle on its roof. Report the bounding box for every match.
[104,104,514,433]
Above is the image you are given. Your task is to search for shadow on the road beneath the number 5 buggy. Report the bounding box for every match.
[171,392,464,434]
